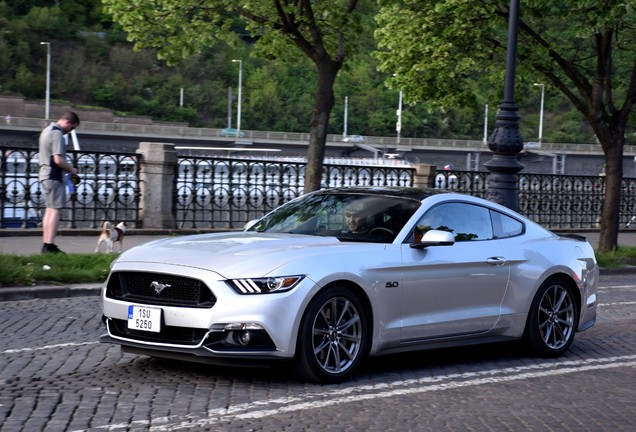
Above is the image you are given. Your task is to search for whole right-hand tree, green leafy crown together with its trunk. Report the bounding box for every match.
[376,0,636,250]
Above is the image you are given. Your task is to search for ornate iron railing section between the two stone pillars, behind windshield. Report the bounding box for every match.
[174,157,413,228]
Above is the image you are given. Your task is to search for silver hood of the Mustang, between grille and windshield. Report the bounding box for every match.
[116,232,352,278]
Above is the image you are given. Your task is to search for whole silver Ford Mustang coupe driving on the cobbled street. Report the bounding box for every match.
[102,188,599,383]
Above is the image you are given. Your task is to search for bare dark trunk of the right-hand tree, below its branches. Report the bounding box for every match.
[598,132,625,252]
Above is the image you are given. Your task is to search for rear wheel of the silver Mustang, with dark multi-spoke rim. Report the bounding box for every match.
[525,278,579,357]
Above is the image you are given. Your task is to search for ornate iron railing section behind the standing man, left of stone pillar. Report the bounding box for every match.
[0,147,141,228]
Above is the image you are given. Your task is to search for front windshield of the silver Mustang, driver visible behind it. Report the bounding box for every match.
[248,193,420,243]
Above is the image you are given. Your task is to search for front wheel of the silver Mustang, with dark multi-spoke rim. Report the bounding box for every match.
[294,287,370,384]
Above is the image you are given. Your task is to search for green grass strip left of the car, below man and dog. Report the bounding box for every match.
[0,254,117,286]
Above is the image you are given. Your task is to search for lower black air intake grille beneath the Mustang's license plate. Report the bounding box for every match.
[108,319,208,345]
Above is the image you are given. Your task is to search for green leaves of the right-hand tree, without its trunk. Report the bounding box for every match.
[374,0,636,137]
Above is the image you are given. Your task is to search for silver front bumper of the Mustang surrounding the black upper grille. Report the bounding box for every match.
[102,265,313,363]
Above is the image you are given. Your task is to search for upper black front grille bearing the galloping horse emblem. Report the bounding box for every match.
[106,272,216,308]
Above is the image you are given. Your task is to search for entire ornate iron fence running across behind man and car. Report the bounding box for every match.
[0,147,636,230]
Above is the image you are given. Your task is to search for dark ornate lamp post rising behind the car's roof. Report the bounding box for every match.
[484,0,524,210]
